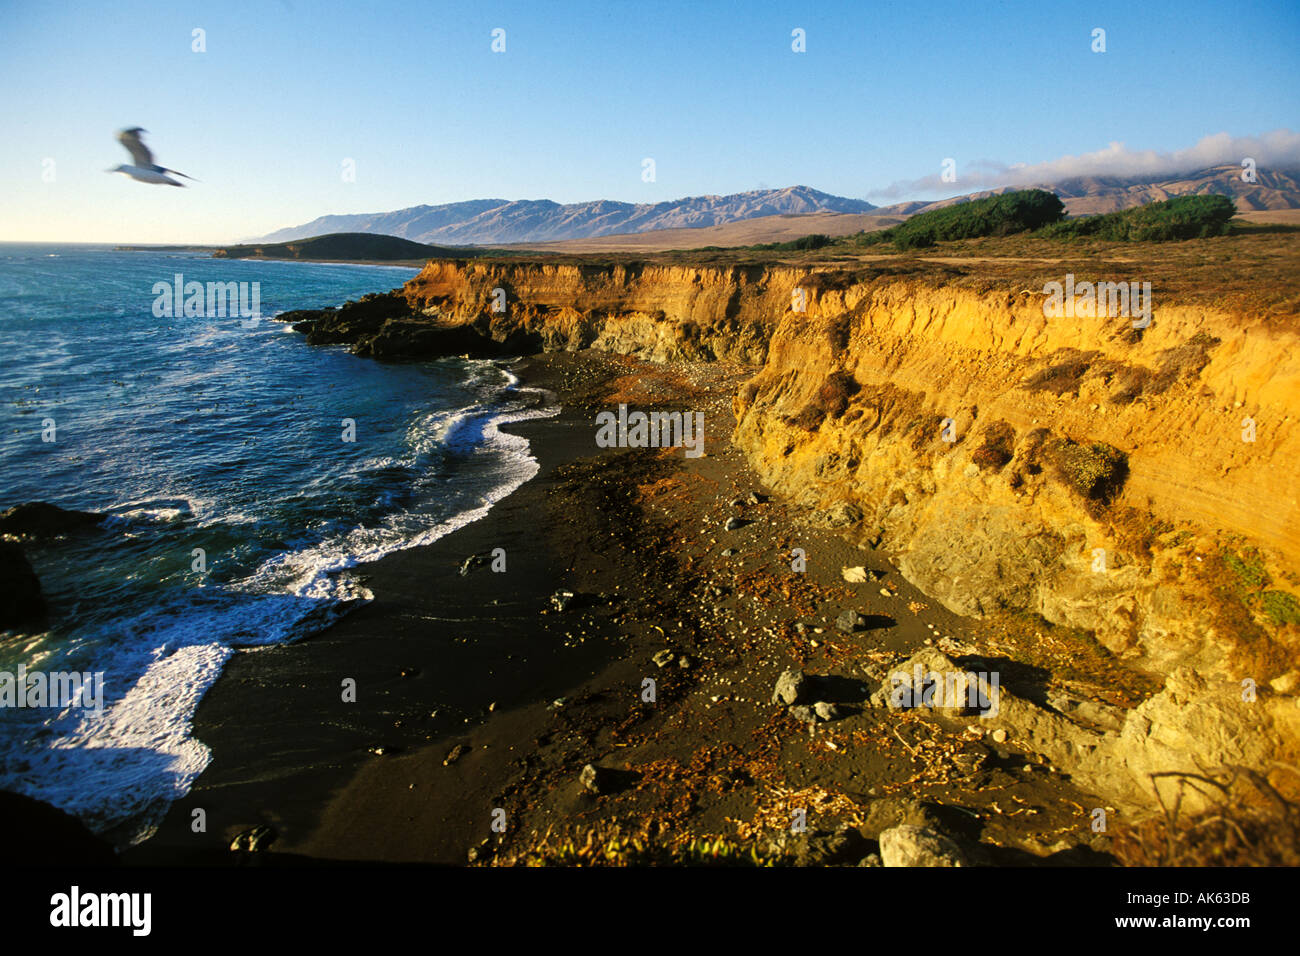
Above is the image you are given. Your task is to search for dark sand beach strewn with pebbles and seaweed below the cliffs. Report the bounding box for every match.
[125,352,1123,865]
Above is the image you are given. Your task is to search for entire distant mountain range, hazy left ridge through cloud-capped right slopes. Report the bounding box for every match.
[252,165,1300,246]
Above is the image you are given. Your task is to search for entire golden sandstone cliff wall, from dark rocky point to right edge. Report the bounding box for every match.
[287,260,1300,806]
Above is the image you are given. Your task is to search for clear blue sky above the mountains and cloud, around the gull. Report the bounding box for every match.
[0,0,1300,242]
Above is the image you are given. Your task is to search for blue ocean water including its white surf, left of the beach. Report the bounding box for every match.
[0,245,549,843]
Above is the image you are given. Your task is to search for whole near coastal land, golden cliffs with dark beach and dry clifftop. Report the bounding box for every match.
[126,233,1300,865]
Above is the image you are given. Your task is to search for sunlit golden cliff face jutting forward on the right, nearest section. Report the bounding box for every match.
[736,285,1300,680]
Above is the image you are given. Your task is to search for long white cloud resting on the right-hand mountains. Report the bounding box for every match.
[868,130,1300,199]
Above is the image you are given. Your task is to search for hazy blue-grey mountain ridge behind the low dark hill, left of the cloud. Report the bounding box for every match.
[255,186,875,246]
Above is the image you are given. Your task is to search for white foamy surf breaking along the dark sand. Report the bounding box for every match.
[5,369,559,843]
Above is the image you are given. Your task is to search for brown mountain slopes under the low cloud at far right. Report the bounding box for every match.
[876,165,1300,216]
